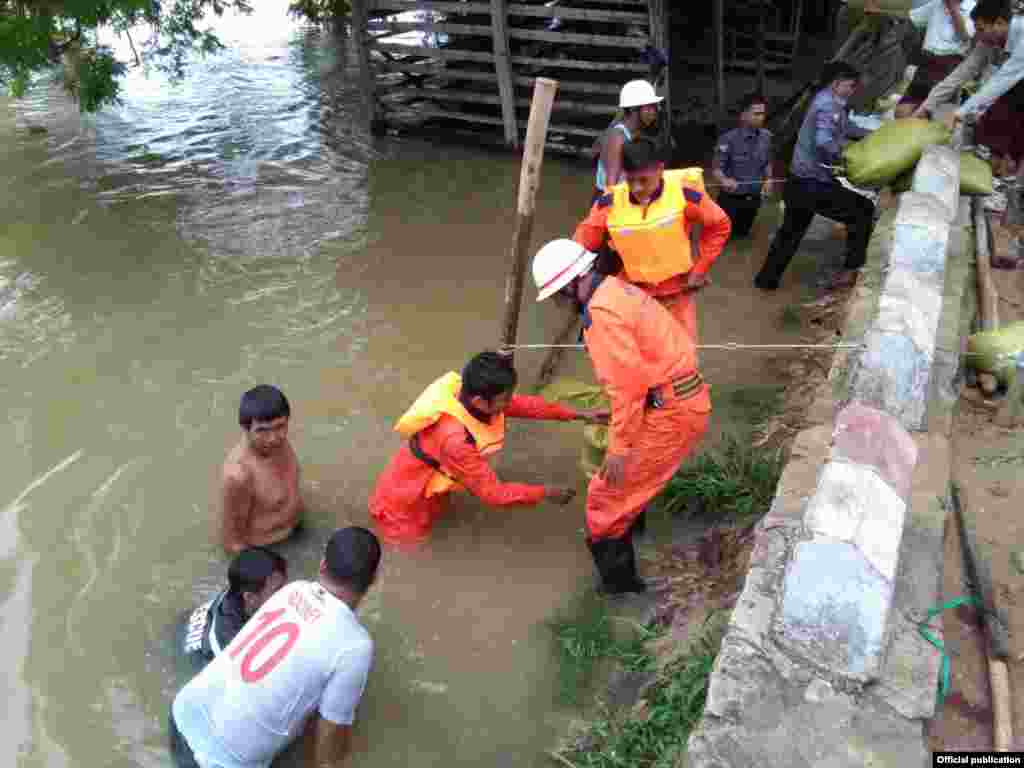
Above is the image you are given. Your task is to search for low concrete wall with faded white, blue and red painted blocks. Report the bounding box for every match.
[688,146,970,768]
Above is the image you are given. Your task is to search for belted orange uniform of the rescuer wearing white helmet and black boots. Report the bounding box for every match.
[584,276,711,540]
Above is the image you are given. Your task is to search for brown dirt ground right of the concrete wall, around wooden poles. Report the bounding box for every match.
[929,221,1024,751]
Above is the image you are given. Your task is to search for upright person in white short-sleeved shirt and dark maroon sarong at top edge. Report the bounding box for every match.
[896,0,976,118]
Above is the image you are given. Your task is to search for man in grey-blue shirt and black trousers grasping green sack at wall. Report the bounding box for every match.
[754,61,874,291]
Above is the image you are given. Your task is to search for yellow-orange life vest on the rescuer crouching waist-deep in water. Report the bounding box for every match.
[394,372,505,499]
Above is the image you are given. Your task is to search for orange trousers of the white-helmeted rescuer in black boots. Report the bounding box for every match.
[587,386,711,540]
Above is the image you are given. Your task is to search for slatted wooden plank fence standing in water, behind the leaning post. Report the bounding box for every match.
[360,0,672,153]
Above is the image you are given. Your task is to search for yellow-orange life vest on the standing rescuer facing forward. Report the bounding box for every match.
[608,168,705,284]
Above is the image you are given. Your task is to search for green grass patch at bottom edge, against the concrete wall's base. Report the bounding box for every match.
[556,612,728,768]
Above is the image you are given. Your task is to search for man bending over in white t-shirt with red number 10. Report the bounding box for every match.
[170,527,381,768]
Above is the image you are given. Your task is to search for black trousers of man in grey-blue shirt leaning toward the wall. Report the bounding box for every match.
[755,176,874,288]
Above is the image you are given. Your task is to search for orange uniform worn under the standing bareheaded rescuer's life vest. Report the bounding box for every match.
[572,171,732,343]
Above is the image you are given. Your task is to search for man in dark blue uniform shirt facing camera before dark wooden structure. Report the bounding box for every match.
[712,93,772,238]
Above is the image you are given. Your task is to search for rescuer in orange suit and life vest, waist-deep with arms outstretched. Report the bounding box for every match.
[370,352,607,546]
